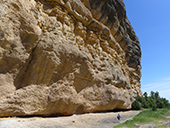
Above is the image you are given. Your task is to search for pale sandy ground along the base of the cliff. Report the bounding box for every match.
[0,111,140,128]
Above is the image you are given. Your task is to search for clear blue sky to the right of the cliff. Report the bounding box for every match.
[123,0,170,101]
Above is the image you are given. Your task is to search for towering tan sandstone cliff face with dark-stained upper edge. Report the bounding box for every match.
[0,0,141,117]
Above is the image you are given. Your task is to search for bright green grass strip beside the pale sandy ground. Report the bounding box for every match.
[114,108,170,128]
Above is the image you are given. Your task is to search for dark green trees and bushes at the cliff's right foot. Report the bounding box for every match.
[132,91,170,111]
